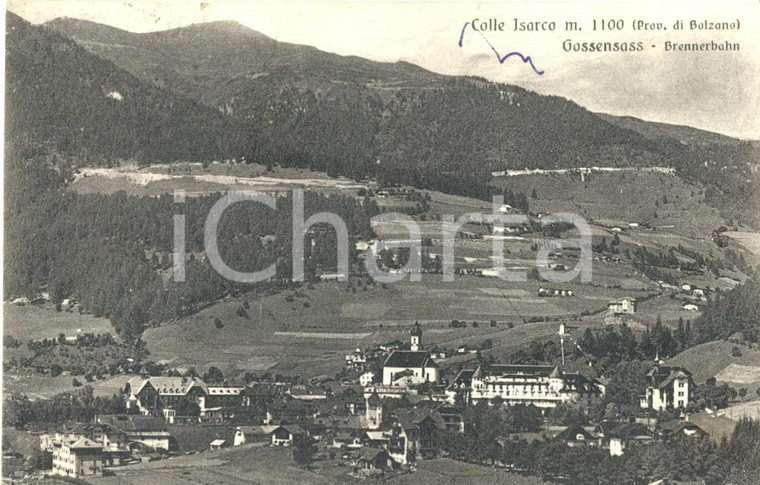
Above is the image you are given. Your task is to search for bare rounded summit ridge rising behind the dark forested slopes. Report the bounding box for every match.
[44,18,439,103]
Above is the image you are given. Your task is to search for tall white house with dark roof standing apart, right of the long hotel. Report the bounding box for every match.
[640,362,694,411]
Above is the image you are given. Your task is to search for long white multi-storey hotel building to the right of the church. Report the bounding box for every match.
[469,363,604,408]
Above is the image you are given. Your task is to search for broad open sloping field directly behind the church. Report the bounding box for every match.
[143,266,651,377]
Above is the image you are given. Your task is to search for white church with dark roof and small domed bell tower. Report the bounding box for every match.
[383,322,438,386]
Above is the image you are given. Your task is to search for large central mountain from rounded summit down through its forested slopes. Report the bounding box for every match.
[45,19,680,180]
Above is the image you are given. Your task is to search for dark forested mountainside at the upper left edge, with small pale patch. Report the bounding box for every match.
[6,12,245,164]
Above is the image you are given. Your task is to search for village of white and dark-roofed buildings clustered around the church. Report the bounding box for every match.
[19,322,706,478]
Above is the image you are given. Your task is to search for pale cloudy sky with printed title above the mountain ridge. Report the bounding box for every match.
[7,0,760,139]
